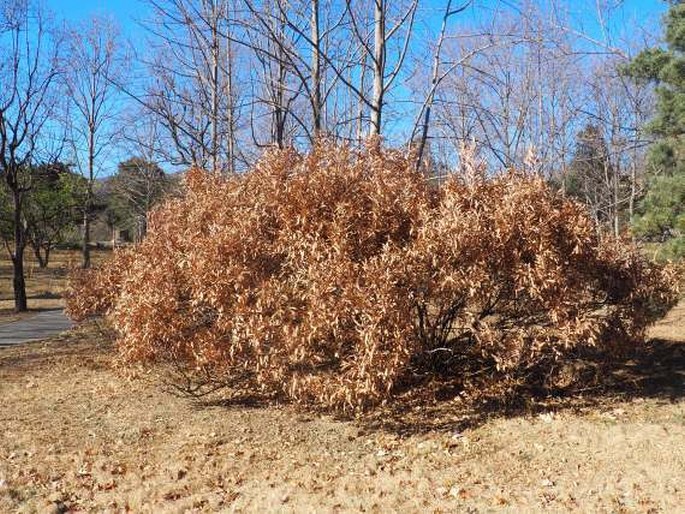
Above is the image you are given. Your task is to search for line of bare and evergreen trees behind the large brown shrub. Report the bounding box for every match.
[0,0,685,310]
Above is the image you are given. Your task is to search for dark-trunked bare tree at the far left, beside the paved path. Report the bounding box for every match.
[0,2,60,312]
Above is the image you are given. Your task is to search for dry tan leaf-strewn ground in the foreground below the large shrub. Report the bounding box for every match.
[0,302,685,513]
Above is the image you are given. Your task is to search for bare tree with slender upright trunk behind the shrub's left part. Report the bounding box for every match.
[136,0,242,173]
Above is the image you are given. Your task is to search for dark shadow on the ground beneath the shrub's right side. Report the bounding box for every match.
[362,339,685,435]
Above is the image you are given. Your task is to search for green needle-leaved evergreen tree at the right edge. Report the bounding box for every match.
[625,2,685,257]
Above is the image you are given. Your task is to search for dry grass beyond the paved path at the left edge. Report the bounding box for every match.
[0,246,111,323]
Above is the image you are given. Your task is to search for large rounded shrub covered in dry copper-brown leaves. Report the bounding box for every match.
[67,144,676,411]
